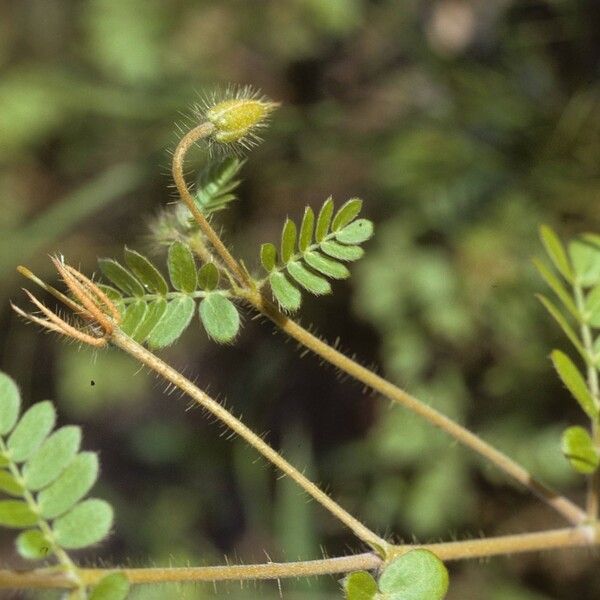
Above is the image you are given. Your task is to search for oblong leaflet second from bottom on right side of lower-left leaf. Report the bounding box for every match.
[37,452,98,519]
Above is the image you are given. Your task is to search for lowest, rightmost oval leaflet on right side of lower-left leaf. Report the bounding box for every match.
[52,498,113,550]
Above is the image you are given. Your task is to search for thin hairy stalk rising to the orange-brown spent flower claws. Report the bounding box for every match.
[111,329,389,554]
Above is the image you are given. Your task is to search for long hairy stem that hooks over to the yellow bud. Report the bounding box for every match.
[173,123,587,525]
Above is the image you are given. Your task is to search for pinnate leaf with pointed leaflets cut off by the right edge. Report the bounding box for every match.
[534,226,600,474]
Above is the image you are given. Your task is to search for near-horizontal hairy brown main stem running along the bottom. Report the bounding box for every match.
[0,527,598,589]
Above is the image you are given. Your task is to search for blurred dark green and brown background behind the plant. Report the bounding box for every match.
[0,0,600,600]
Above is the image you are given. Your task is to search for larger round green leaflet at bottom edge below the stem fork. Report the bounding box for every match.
[379,549,448,600]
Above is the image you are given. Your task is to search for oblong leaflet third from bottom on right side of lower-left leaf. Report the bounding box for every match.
[23,425,81,490]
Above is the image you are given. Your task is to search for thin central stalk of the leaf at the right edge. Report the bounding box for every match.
[573,282,600,521]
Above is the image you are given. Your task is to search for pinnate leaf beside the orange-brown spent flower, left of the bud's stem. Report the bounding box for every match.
[98,241,240,349]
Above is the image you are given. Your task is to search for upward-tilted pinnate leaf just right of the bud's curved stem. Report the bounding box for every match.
[260,198,373,312]
